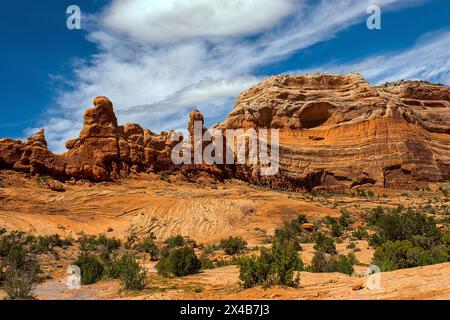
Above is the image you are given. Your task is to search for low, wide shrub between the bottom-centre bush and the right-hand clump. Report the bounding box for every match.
[309,251,356,275]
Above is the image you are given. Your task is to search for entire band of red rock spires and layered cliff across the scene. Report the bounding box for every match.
[0,74,450,189]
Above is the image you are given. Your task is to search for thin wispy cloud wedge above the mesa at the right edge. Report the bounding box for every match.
[291,30,450,85]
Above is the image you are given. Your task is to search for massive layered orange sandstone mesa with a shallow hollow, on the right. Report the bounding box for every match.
[218,74,450,189]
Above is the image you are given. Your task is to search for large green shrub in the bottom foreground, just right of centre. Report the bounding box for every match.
[239,242,303,288]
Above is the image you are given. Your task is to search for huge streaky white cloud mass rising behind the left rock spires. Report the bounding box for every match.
[33,0,430,152]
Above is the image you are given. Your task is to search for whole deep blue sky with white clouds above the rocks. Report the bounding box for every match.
[0,0,450,152]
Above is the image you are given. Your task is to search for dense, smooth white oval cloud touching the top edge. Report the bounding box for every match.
[102,0,294,43]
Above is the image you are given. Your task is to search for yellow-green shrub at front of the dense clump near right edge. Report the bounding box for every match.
[373,240,448,271]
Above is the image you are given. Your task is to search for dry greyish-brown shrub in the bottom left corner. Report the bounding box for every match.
[0,247,40,299]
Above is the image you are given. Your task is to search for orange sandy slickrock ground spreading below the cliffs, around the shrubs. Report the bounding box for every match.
[0,171,450,299]
